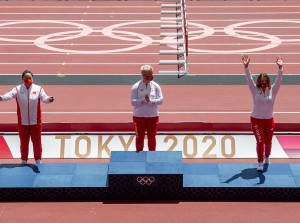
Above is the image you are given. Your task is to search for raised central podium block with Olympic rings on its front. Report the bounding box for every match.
[108,151,183,199]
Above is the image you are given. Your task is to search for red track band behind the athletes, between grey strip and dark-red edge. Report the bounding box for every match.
[0,85,300,123]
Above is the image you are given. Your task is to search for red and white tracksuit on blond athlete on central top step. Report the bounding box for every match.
[131,80,163,151]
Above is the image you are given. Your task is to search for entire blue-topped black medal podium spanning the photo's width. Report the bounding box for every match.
[0,151,300,201]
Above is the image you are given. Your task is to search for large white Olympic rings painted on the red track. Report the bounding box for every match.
[0,20,300,54]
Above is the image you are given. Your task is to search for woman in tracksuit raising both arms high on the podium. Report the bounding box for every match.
[242,55,283,171]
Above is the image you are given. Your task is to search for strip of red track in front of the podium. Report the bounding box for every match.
[0,201,300,223]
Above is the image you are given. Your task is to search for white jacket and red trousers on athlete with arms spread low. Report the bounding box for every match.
[2,84,50,161]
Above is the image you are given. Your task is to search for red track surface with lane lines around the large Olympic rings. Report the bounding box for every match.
[0,1,300,74]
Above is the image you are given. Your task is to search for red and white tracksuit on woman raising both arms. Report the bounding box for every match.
[245,68,283,162]
